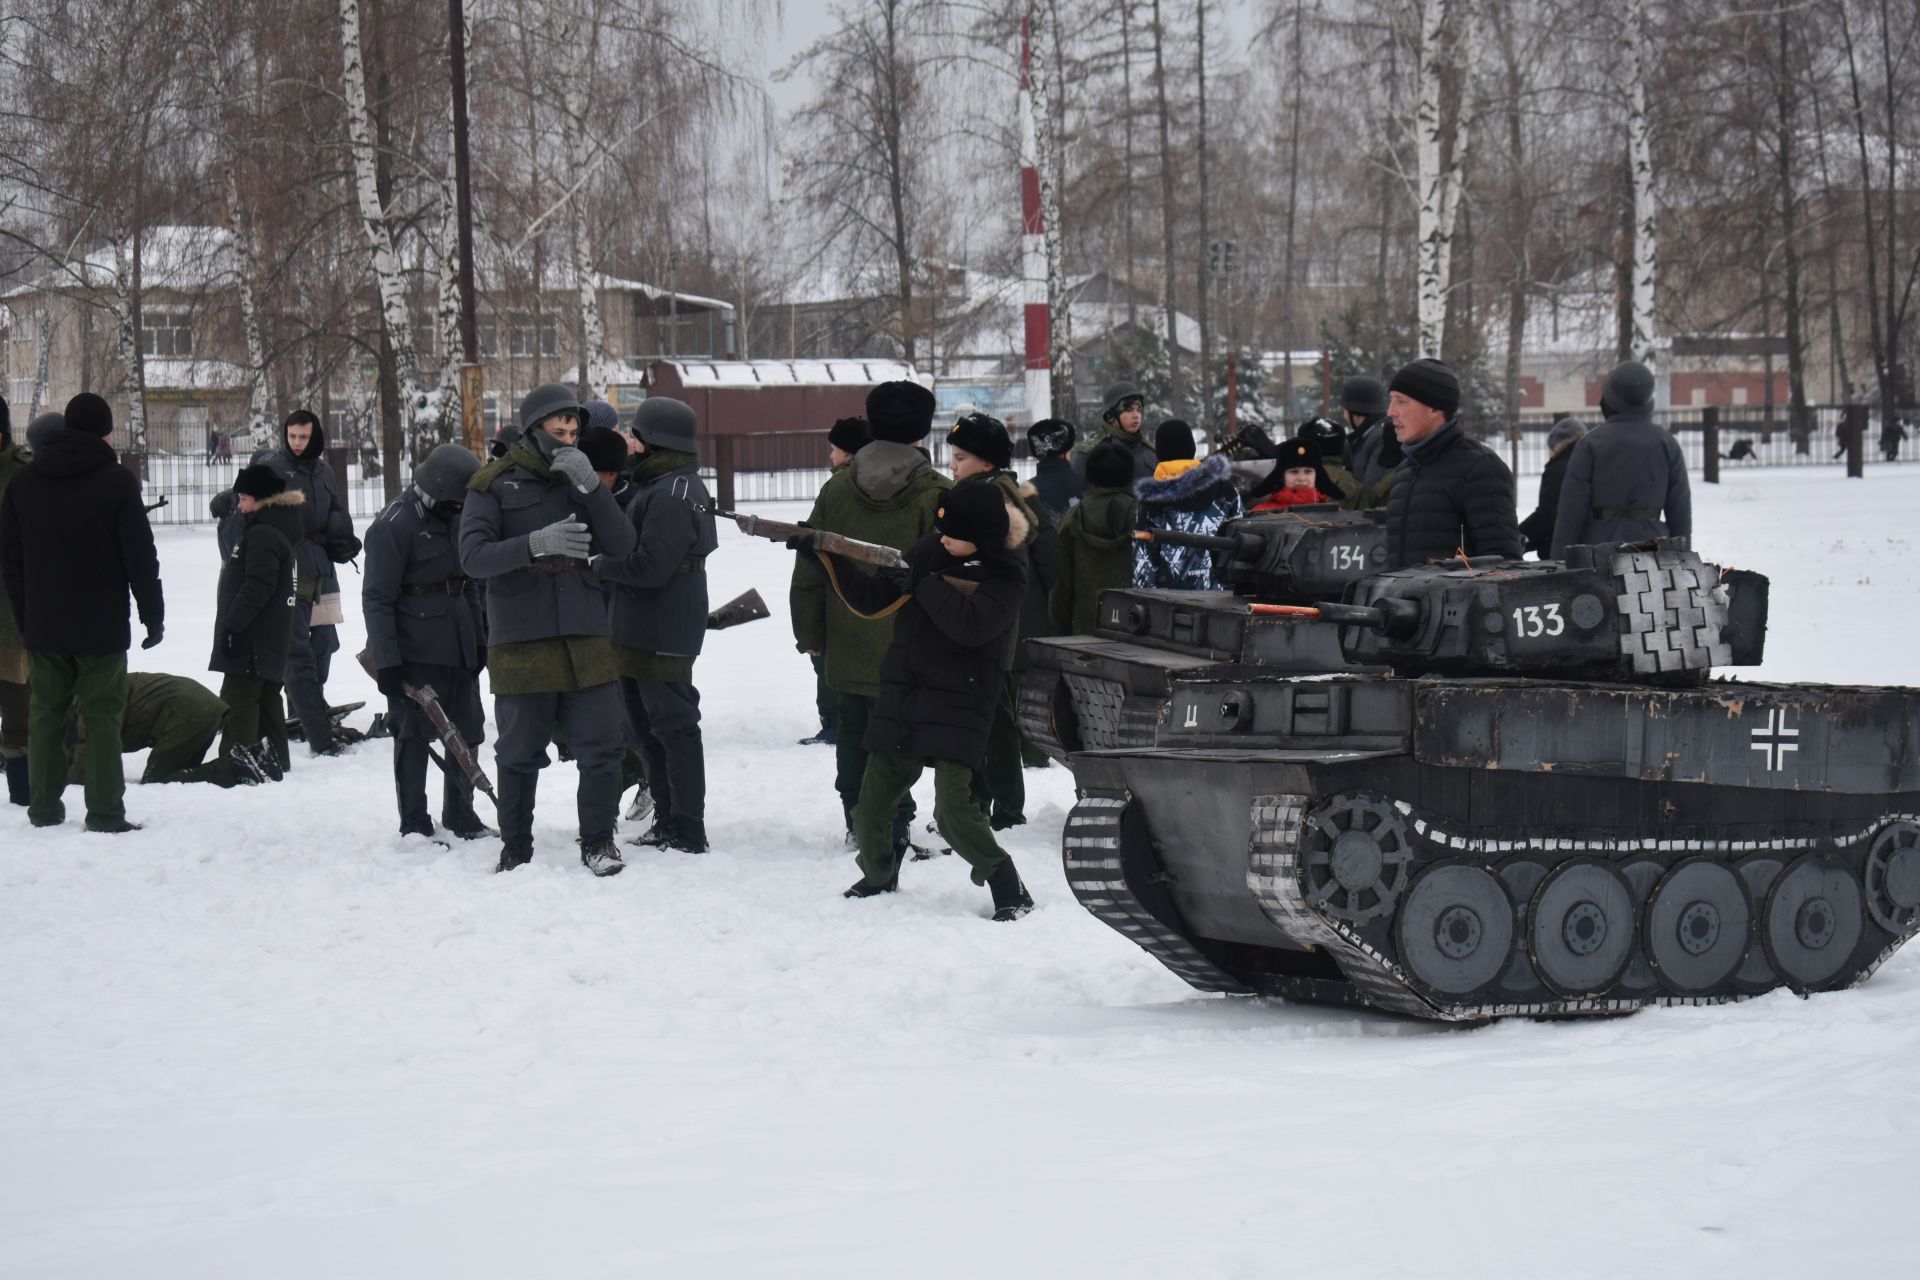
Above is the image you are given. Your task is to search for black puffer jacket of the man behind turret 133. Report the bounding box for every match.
[1386,420,1523,568]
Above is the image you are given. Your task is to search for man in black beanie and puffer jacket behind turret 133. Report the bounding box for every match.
[1386,361,1523,568]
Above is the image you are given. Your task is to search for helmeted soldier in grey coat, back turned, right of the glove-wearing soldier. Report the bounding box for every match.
[595,395,720,854]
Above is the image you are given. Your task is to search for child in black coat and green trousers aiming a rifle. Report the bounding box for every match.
[797,484,1033,921]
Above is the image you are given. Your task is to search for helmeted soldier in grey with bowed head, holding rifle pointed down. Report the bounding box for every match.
[361,443,493,841]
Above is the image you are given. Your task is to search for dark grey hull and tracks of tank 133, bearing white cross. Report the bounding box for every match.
[1064,677,1920,1021]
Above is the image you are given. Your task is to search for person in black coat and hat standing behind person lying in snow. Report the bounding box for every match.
[207,464,307,775]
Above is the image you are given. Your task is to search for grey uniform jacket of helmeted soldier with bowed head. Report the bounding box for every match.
[361,489,486,672]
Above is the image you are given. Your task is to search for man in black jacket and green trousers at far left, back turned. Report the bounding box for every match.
[0,391,165,833]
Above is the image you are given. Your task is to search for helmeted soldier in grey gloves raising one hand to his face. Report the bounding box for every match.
[459,382,634,875]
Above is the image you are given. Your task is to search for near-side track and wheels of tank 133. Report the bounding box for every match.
[1246,794,1920,1021]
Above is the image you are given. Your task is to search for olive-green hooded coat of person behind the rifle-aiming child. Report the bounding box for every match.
[789,439,950,697]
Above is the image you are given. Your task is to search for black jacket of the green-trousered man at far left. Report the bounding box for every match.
[0,428,167,654]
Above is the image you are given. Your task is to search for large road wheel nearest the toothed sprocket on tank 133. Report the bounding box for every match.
[1394,862,1513,996]
